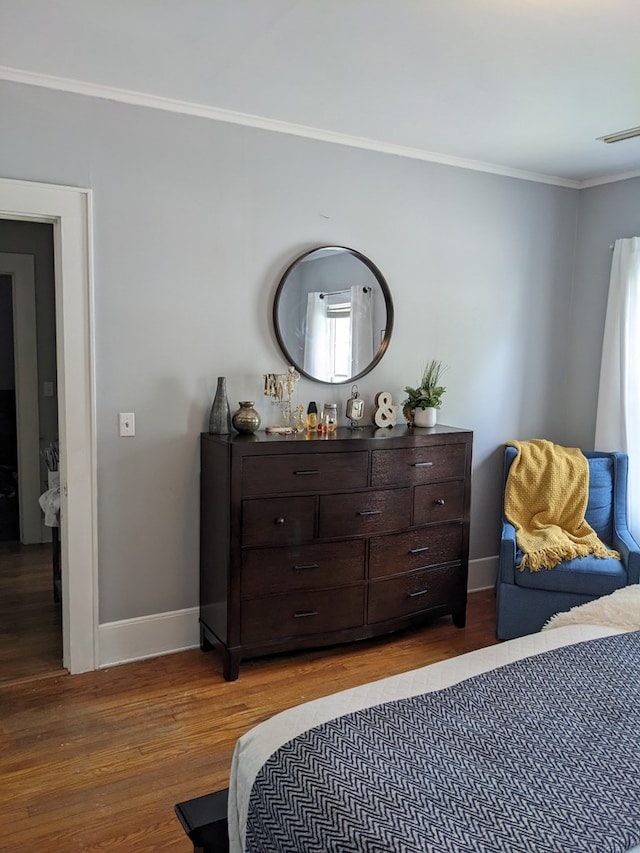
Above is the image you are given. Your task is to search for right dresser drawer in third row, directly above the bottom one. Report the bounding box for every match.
[369,524,462,578]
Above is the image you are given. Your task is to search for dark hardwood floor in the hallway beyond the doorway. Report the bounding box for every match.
[0,542,63,686]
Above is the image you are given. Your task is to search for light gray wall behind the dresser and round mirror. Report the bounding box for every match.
[0,83,588,622]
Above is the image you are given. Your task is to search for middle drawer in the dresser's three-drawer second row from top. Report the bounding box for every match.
[319,489,411,539]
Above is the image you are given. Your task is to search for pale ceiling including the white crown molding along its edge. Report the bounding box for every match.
[0,0,640,186]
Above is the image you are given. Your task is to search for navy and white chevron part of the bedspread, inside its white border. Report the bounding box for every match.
[246,632,640,853]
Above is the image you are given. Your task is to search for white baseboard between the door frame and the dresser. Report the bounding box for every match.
[98,607,200,669]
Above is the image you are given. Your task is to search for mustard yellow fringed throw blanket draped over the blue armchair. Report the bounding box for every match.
[504,438,620,572]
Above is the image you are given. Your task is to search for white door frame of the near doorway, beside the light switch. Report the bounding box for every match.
[0,178,99,673]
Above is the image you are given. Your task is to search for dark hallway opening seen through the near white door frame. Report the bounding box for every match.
[0,233,62,682]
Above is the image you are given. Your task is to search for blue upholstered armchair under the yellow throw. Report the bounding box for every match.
[496,446,640,640]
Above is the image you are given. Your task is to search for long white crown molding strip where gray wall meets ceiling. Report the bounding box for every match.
[0,66,628,189]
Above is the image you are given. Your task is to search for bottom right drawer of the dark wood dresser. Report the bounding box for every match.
[368,566,465,623]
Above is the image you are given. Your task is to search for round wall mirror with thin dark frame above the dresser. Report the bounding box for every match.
[273,246,393,384]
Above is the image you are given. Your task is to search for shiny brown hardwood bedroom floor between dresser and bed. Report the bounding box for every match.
[0,591,496,853]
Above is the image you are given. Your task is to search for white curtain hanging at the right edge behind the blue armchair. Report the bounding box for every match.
[595,237,640,541]
